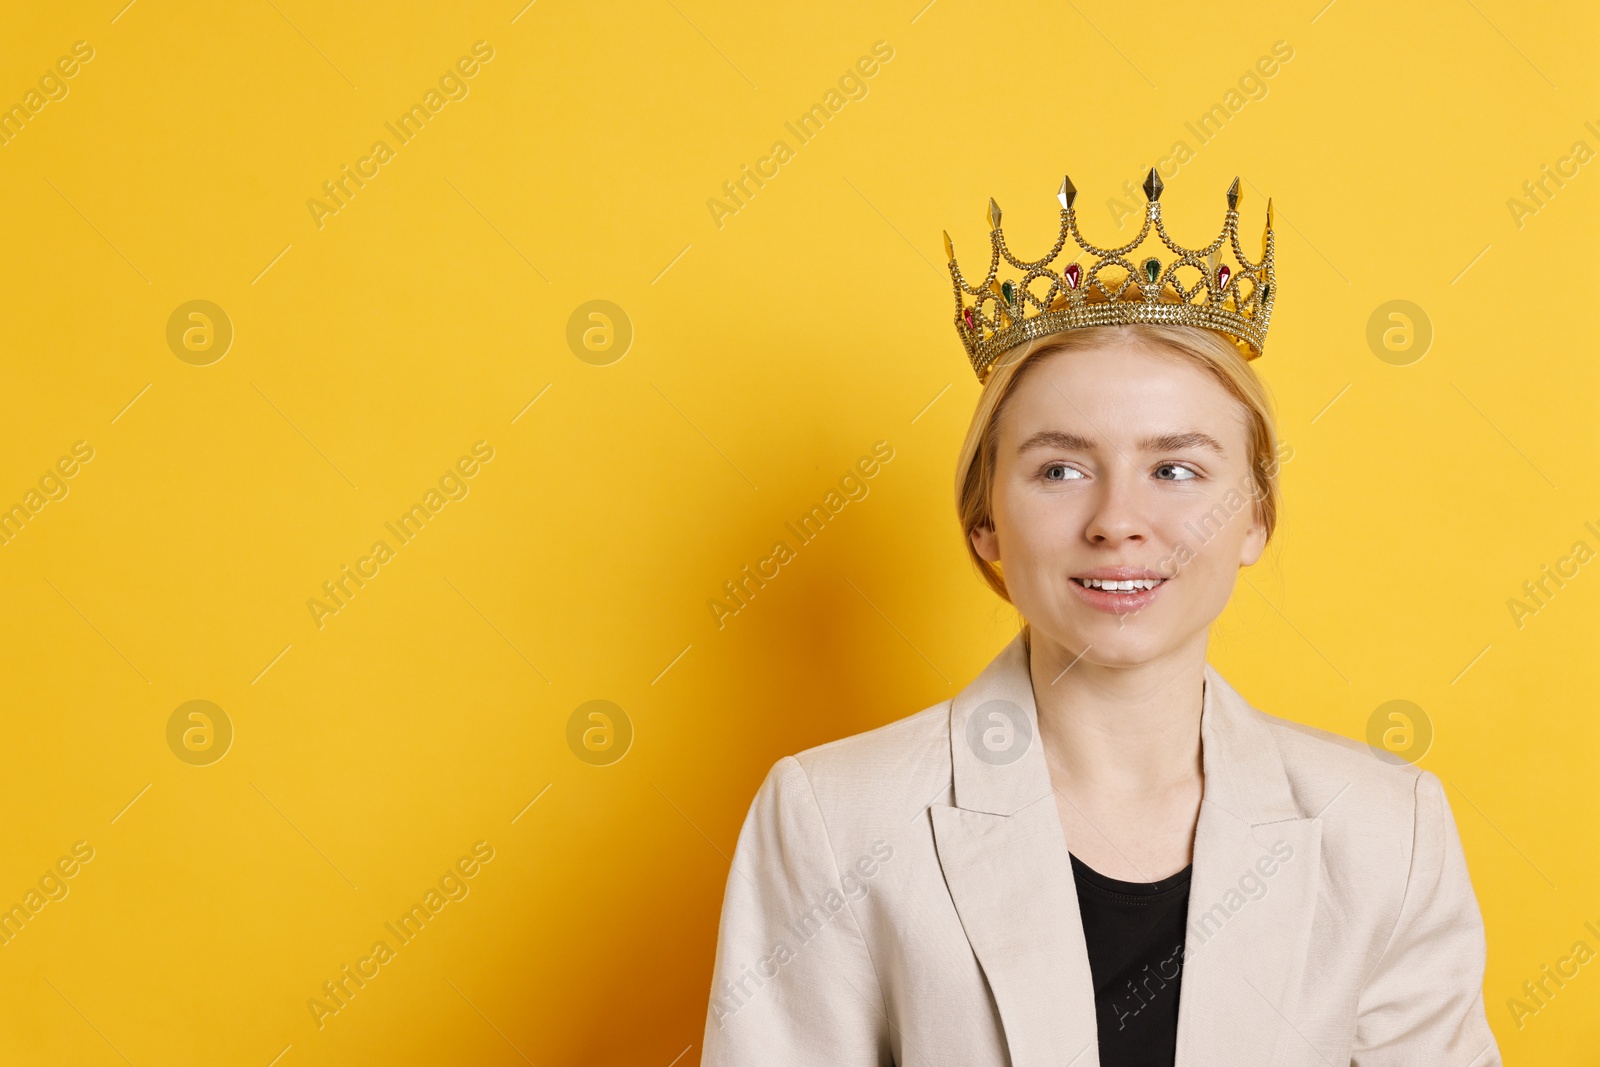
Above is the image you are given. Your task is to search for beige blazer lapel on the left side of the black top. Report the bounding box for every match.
[933,637,1099,1067]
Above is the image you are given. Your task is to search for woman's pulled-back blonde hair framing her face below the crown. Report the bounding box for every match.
[955,323,1280,601]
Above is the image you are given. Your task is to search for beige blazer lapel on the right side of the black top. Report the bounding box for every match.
[1176,664,1322,1067]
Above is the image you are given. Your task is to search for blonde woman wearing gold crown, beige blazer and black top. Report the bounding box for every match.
[702,170,1501,1067]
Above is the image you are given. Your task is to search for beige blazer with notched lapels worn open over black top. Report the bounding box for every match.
[701,637,1501,1067]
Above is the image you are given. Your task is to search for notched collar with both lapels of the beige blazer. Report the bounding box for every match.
[931,635,1322,1067]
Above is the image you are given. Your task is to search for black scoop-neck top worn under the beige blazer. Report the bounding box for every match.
[1072,856,1194,1067]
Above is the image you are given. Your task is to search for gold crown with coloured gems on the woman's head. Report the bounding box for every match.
[944,166,1277,381]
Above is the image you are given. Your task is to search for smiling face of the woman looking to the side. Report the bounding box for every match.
[971,341,1266,667]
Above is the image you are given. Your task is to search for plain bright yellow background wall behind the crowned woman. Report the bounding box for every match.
[0,0,1600,1067]
